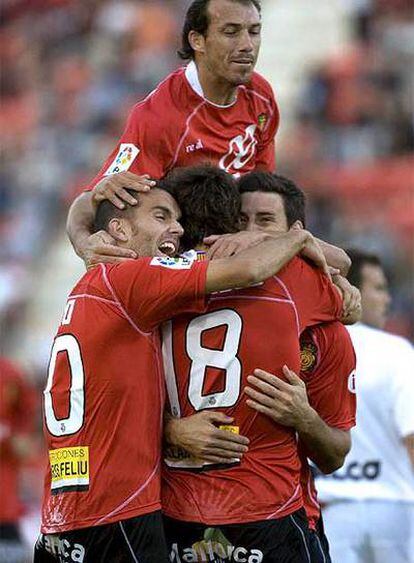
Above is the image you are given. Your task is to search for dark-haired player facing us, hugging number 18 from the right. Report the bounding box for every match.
[239,172,356,563]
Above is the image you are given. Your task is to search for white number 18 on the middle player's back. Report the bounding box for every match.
[163,309,243,416]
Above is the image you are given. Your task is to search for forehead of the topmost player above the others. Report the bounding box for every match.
[208,0,261,27]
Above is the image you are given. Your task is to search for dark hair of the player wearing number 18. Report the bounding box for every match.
[160,165,241,250]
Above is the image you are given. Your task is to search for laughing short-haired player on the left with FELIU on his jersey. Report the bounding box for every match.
[35,178,323,563]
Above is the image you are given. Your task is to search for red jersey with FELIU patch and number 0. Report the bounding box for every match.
[42,258,207,533]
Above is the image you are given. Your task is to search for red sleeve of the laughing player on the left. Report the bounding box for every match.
[105,258,208,332]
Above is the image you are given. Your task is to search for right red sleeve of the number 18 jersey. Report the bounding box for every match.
[281,258,343,332]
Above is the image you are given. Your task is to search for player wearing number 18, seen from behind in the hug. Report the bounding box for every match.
[162,165,342,563]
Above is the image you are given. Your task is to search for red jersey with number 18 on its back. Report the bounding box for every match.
[162,258,342,525]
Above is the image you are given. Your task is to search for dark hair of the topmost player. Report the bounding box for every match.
[178,0,262,61]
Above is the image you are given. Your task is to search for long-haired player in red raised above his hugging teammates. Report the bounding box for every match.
[68,0,279,263]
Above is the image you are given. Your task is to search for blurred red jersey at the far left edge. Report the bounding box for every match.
[0,358,36,524]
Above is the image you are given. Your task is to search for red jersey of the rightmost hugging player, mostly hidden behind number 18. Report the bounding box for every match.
[299,322,356,529]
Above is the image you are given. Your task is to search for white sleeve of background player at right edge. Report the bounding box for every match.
[390,341,414,438]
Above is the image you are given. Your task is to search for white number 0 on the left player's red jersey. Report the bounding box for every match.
[44,334,85,436]
